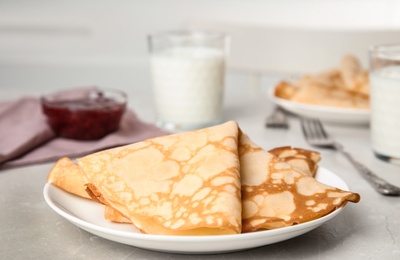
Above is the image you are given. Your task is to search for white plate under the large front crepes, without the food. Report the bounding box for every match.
[43,167,348,254]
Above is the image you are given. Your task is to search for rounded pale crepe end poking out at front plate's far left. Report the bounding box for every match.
[47,157,90,199]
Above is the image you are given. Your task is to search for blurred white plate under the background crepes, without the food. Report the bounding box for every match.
[268,88,370,124]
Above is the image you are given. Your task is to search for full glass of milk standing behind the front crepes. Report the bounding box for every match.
[148,31,229,132]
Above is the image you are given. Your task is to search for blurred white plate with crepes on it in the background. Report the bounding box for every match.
[268,55,370,124]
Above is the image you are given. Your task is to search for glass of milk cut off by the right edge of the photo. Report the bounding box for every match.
[369,43,400,163]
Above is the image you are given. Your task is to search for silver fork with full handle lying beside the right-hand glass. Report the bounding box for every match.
[301,118,400,196]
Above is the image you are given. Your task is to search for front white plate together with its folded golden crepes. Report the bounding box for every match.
[44,121,360,254]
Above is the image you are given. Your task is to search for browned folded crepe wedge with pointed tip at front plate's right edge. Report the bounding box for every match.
[239,134,360,232]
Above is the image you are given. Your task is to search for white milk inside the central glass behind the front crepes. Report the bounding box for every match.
[151,47,225,128]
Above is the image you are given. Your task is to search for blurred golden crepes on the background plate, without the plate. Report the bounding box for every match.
[275,55,370,109]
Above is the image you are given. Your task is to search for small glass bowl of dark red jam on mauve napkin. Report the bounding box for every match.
[41,87,127,140]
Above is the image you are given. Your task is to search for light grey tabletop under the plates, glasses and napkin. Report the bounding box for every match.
[0,63,400,259]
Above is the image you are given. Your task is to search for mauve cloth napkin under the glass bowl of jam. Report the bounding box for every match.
[0,97,169,169]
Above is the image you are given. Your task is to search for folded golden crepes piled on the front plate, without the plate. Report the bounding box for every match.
[47,121,360,235]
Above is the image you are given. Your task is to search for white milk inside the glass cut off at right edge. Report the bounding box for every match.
[370,66,400,158]
